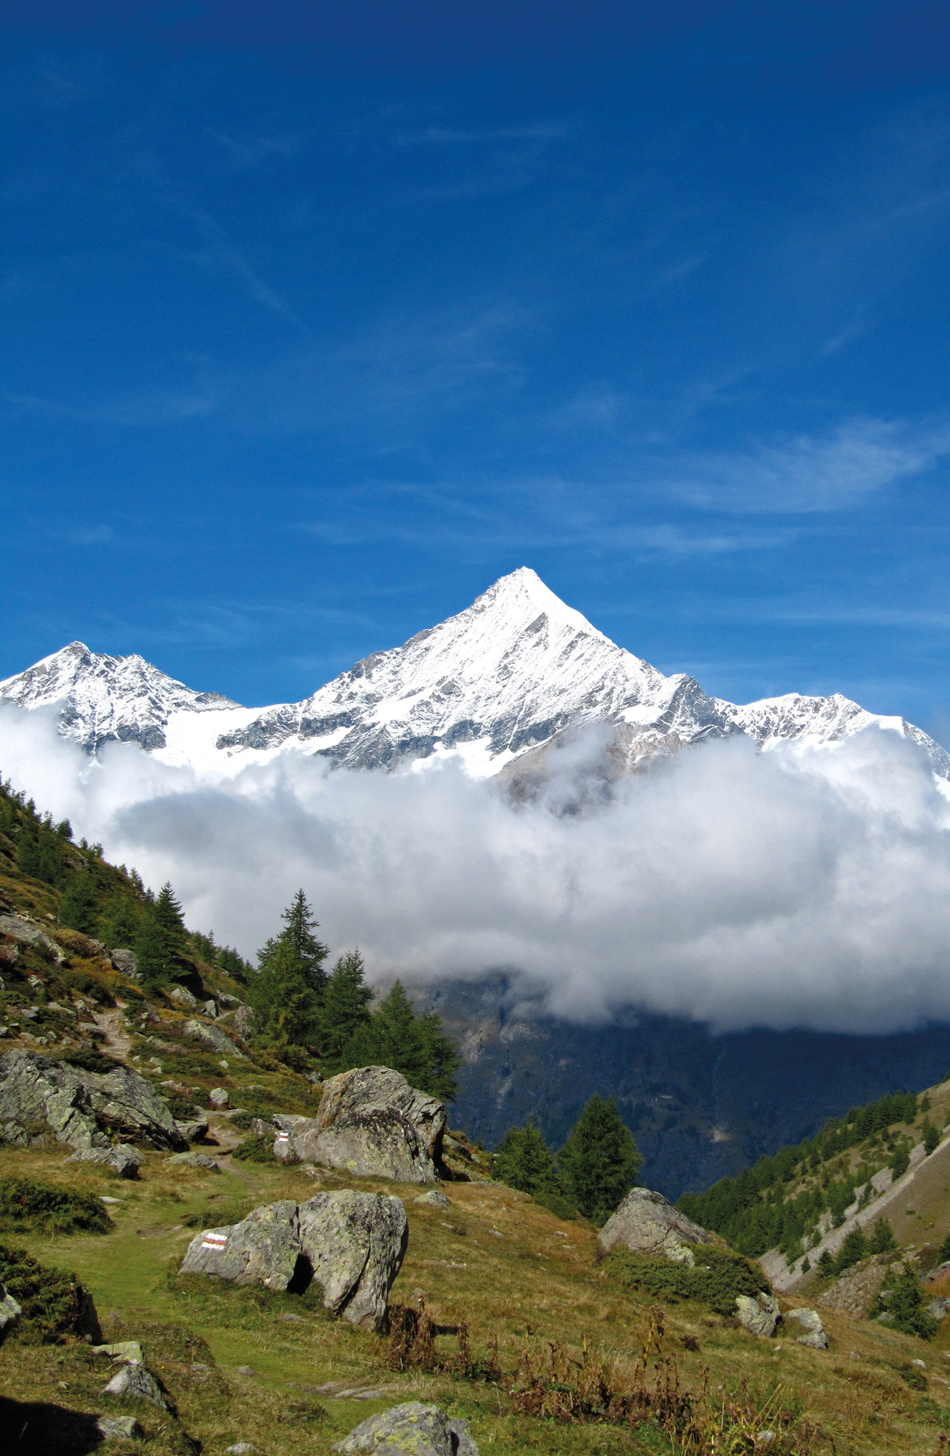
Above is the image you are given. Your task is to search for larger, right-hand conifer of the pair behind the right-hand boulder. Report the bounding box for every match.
[558,1096,643,1224]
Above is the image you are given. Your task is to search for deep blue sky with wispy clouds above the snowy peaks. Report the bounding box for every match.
[0,0,950,728]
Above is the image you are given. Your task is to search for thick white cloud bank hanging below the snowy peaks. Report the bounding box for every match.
[0,708,950,1032]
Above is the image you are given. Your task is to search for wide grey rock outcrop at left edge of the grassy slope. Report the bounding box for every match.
[0,1051,187,1152]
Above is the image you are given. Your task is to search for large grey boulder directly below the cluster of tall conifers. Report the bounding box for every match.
[274,1067,446,1184]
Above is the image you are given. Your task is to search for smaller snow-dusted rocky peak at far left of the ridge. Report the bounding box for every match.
[0,642,238,753]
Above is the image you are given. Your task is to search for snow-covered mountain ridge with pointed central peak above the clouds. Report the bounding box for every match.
[0,566,950,779]
